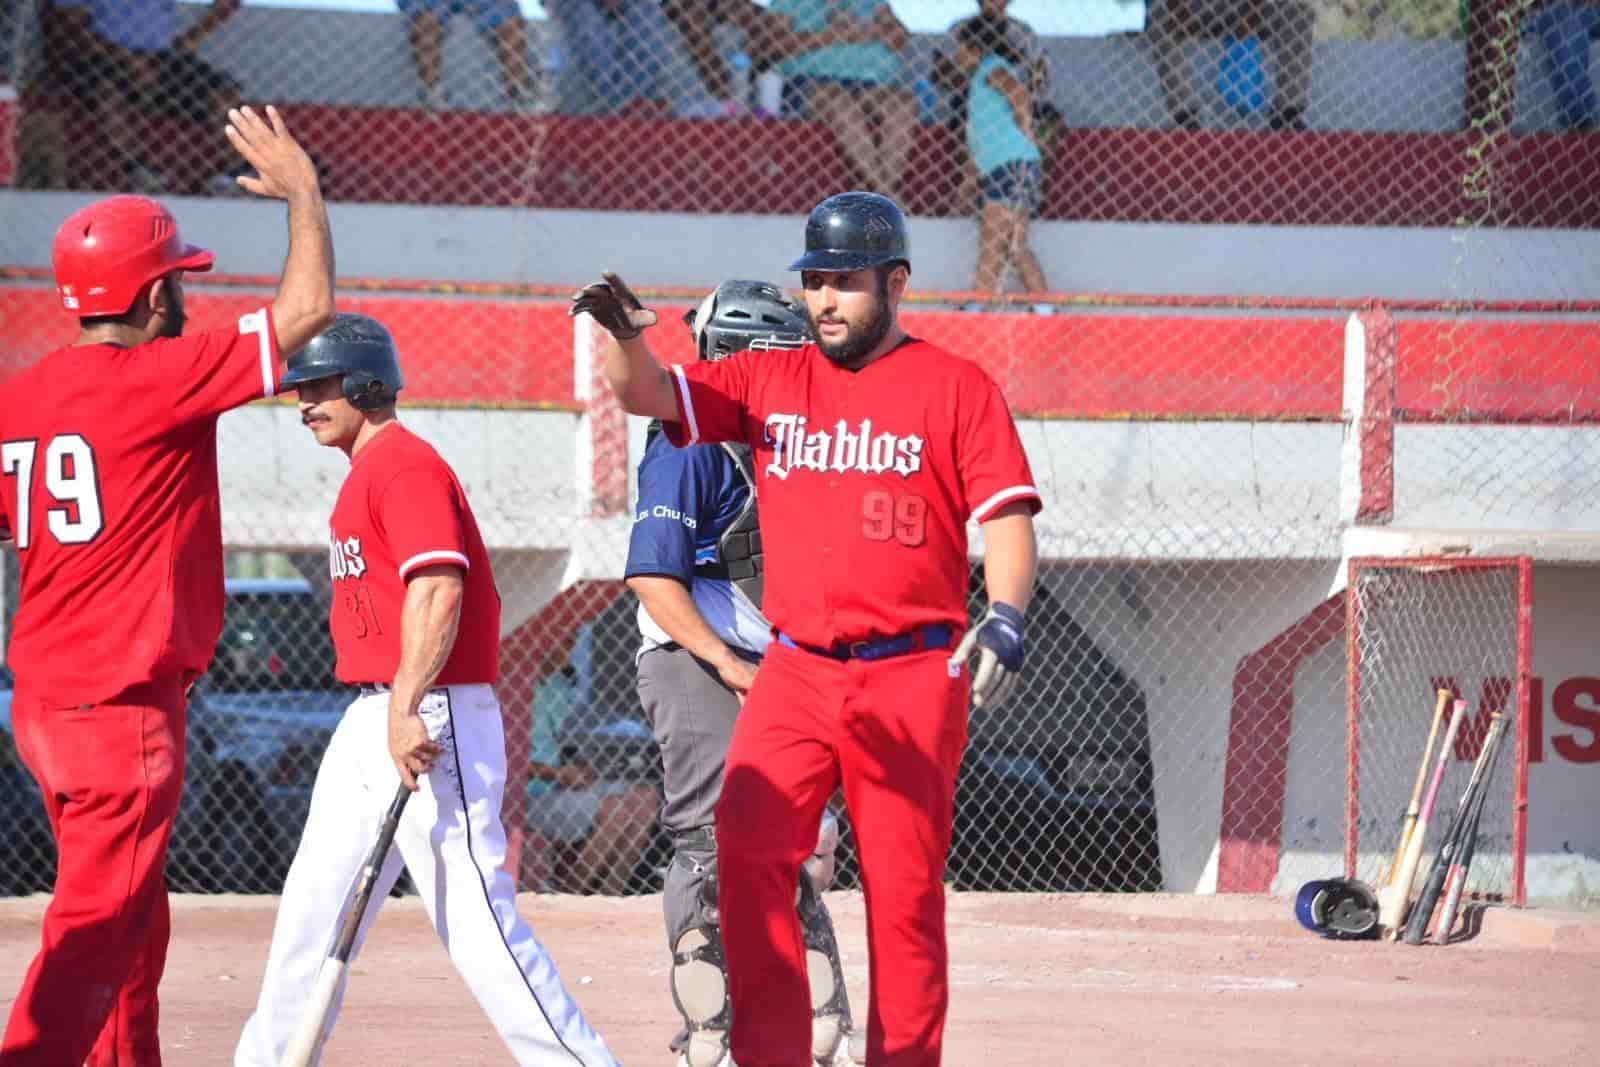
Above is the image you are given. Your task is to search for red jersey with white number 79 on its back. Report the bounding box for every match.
[0,309,278,705]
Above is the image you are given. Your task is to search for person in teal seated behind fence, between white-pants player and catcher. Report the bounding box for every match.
[525,664,659,896]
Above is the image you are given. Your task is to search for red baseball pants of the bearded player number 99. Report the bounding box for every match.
[717,643,968,1067]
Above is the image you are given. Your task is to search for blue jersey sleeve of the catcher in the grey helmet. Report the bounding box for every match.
[622,437,710,585]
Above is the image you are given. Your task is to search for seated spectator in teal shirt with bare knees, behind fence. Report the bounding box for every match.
[771,0,917,200]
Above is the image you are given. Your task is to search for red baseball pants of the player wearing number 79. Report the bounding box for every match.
[0,678,184,1067]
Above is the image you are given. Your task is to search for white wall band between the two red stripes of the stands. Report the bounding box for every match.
[0,190,1600,301]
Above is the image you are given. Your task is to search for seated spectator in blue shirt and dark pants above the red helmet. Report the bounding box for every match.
[42,0,242,194]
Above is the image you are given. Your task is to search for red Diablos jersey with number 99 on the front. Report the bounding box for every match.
[664,338,1040,646]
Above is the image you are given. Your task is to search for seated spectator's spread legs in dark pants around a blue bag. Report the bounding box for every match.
[1146,0,1317,130]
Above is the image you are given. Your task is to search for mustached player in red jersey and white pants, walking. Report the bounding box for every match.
[234,315,616,1067]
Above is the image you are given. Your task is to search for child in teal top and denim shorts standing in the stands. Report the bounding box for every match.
[955,19,1050,294]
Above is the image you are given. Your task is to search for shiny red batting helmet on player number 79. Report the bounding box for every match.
[50,197,216,318]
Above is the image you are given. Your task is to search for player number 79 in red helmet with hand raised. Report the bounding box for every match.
[0,107,333,1067]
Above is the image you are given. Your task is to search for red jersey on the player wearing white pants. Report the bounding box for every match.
[328,422,499,685]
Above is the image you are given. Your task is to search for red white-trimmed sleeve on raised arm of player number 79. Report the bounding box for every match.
[152,307,278,422]
